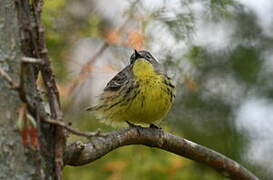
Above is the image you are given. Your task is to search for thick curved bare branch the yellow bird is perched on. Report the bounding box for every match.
[64,127,258,180]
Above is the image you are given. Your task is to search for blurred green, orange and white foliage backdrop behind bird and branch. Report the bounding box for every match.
[41,0,273,180]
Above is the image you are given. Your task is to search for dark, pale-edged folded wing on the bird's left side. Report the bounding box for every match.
[104,65,131,91]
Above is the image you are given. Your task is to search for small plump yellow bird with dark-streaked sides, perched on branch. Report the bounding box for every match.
[87,50,175,124]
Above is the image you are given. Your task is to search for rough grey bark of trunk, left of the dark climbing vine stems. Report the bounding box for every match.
[0,0,36,179]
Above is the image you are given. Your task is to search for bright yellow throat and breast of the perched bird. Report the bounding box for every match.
[123,59,172,123]
